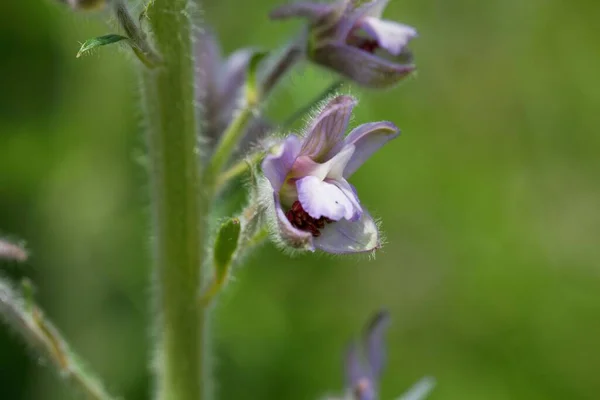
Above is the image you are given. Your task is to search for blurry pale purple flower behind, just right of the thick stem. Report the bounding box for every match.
[196,31,269,152]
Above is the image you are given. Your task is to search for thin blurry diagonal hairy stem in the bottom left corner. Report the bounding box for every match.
[0,278,113,400]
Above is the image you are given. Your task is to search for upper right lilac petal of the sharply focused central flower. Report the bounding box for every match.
[344,121,400,178]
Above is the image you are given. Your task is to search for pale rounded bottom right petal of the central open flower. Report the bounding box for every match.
[314,210,380,254]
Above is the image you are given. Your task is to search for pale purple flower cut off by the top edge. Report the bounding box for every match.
[271,0,417,88]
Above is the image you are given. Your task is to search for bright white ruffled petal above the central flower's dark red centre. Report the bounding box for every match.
[296,176,362,221]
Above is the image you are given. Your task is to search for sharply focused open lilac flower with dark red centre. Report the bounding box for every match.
[262,95,399,253]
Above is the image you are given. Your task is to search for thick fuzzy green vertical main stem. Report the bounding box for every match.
[142,0,208,400]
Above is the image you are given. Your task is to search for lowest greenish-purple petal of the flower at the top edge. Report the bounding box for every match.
[313,43,415,88]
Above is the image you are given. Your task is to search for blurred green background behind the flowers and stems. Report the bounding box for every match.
[0,0,600,400]
